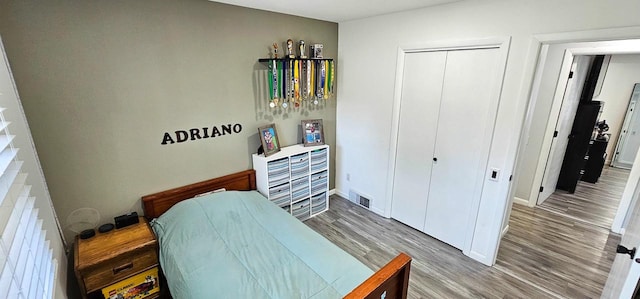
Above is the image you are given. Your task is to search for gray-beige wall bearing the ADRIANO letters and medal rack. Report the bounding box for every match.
[0,0,338,240]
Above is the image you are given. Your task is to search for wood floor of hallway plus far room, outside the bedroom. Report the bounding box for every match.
[496,167,630,298]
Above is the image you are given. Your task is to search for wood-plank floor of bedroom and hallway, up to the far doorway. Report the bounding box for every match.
[305,196,619,298]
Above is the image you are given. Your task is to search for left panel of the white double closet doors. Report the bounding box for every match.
[391,52,446,231]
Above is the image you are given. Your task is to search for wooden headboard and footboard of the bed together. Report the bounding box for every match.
[142,169,411,299]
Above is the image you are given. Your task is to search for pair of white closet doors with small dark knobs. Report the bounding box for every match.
[391,48,501,249]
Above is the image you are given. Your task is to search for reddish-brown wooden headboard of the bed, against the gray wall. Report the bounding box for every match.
[142,169,256,220]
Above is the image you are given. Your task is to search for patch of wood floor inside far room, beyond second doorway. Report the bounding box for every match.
[539,167,629,228]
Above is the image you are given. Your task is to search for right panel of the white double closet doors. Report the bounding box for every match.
[424,48,499,249]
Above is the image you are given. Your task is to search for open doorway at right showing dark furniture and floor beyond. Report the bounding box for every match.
[537,54,640,228]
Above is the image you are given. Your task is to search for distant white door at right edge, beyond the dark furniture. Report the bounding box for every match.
[612,83,640,169]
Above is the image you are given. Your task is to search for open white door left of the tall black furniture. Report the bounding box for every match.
[538,56,593,204]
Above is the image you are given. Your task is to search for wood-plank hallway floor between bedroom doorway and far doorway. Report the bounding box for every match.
[495,204,620,298]
